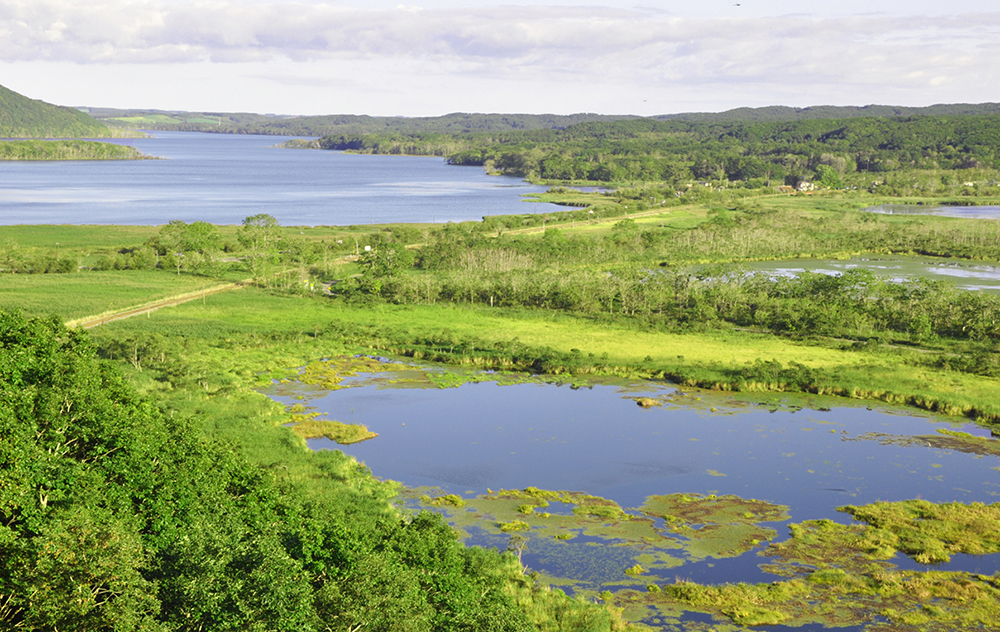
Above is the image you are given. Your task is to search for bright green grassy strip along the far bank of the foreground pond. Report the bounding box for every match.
[84,289,1000,423]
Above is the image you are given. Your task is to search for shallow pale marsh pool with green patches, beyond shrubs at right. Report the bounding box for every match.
[743,255,1000,292]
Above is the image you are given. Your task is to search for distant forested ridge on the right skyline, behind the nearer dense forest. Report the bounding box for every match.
[651,103,1000,123]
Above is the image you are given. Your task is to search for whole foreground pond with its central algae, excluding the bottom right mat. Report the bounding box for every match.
[268,357,1000,629]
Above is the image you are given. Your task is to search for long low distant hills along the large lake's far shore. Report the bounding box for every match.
[89,108,637,136]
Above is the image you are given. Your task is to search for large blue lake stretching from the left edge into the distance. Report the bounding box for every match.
[0,132,565,226]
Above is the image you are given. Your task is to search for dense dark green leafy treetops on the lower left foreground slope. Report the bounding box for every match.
[0,312,624,631]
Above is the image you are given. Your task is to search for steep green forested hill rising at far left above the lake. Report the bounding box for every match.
[0,86,112,138]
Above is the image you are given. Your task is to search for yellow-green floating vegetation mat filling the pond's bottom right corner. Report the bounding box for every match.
[613,500,1000,631]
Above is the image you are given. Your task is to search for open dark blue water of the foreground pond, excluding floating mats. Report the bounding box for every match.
[269,364,1000,612]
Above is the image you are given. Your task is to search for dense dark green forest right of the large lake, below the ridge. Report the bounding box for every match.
[308,114,1000,188]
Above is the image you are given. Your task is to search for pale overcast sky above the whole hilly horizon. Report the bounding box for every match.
[0,0,1000,116]
